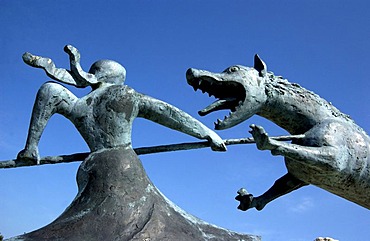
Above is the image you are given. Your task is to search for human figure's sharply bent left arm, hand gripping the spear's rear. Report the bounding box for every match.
[17,82,77,162]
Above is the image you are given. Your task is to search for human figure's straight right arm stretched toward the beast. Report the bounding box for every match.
[138,94,226,151]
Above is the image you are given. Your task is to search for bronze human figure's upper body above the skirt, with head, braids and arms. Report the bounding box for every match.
[18,45,226,162]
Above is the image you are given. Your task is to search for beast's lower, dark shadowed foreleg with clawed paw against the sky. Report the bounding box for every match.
[235,172,308,211]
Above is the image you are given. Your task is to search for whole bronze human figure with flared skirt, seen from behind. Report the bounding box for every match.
[9,45,260,241]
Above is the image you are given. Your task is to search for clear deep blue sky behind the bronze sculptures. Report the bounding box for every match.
[0,0,370,241]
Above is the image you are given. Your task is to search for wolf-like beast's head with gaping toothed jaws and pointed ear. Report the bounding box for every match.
[186,55,268,130]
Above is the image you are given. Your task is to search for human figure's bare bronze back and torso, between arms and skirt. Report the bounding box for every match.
[72,85,138,151]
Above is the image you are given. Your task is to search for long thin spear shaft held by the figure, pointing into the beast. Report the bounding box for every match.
[0,135,304,169]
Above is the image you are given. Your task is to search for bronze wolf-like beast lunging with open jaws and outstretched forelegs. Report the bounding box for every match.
[186,55,370,211]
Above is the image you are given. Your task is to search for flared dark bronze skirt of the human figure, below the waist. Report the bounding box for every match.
[8,147,260,241]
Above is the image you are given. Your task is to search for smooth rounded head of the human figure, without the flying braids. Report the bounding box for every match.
[89,60,126,85]
